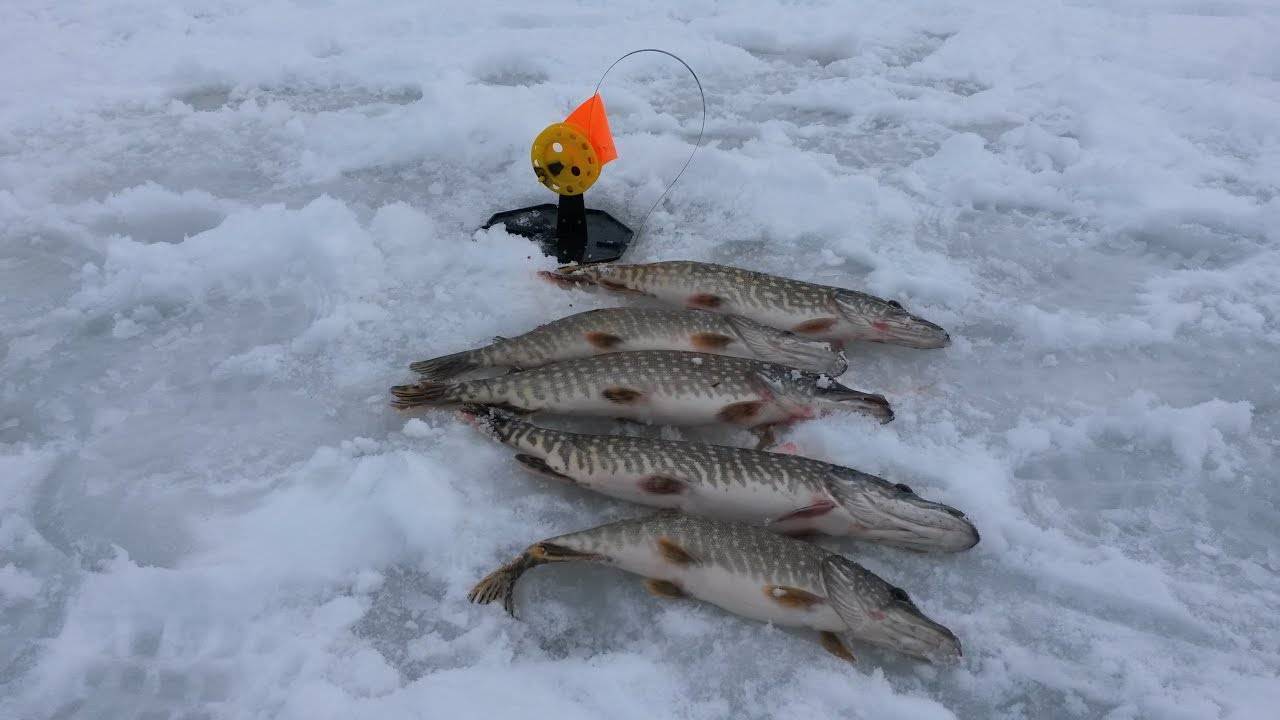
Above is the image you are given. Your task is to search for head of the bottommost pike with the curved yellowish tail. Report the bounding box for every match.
[822,555,964,662]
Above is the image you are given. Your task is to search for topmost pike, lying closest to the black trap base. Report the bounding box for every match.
[541,260,951,347]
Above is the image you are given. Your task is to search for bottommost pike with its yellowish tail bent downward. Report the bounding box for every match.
[468,511,961,661]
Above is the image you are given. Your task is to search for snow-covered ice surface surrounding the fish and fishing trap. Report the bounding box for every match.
[0,0,1280,720]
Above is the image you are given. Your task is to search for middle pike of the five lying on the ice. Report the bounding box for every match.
[392,350,893,428]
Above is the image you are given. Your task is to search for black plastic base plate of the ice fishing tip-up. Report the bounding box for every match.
[484,196,635,263]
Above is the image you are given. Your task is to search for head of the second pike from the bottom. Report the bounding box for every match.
[828,470,980,552]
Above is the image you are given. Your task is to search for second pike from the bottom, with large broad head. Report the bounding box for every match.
[463,405,978,552]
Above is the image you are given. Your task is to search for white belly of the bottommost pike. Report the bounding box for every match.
[609,543,847,632]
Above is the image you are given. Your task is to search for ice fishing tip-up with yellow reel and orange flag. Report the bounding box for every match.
[484,49,707,263]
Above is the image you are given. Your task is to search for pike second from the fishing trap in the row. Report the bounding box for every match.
[410,307,847,380]
